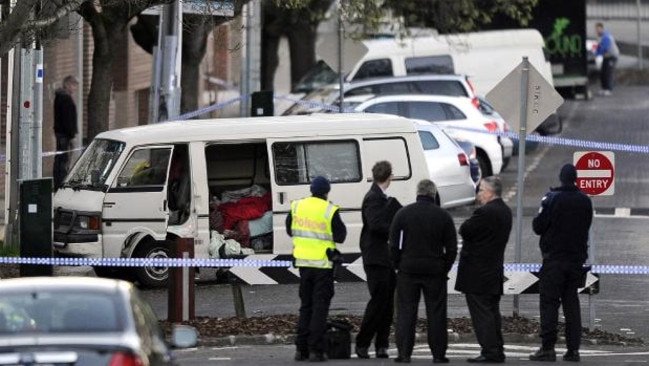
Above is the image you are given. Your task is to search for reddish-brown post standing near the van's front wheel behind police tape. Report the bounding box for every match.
[167,238,195,323]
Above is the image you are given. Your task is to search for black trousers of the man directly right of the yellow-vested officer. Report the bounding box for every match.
[356,266,396,348]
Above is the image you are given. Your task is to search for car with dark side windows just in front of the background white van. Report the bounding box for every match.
[284,75,479,116]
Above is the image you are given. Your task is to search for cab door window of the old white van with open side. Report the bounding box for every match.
[117,148,171,187]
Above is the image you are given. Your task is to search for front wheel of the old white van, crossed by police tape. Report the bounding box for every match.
[133,240,170,287]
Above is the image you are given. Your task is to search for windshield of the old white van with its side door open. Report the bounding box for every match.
[63,139,126,189]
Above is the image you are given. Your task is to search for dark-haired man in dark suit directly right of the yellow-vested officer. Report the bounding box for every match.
[356,160,401,358]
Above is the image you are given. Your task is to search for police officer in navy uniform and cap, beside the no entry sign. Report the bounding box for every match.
[529,164,593,362]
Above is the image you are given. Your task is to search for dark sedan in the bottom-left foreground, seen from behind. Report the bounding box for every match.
[0,276,197,366]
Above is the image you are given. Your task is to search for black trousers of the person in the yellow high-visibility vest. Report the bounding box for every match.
[295,267,334,354]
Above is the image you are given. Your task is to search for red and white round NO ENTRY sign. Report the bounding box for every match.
[573,151,615,196]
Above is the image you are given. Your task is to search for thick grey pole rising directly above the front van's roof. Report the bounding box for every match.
[149,0,183,123]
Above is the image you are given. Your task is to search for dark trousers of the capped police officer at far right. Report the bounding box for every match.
[539,260,584,350]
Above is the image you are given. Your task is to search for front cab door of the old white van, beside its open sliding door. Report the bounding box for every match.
[102,145,173,257]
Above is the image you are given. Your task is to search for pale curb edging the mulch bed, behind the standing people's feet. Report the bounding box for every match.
[198,332,645,347]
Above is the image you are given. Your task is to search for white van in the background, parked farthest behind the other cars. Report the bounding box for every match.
[292,29,552,98]
